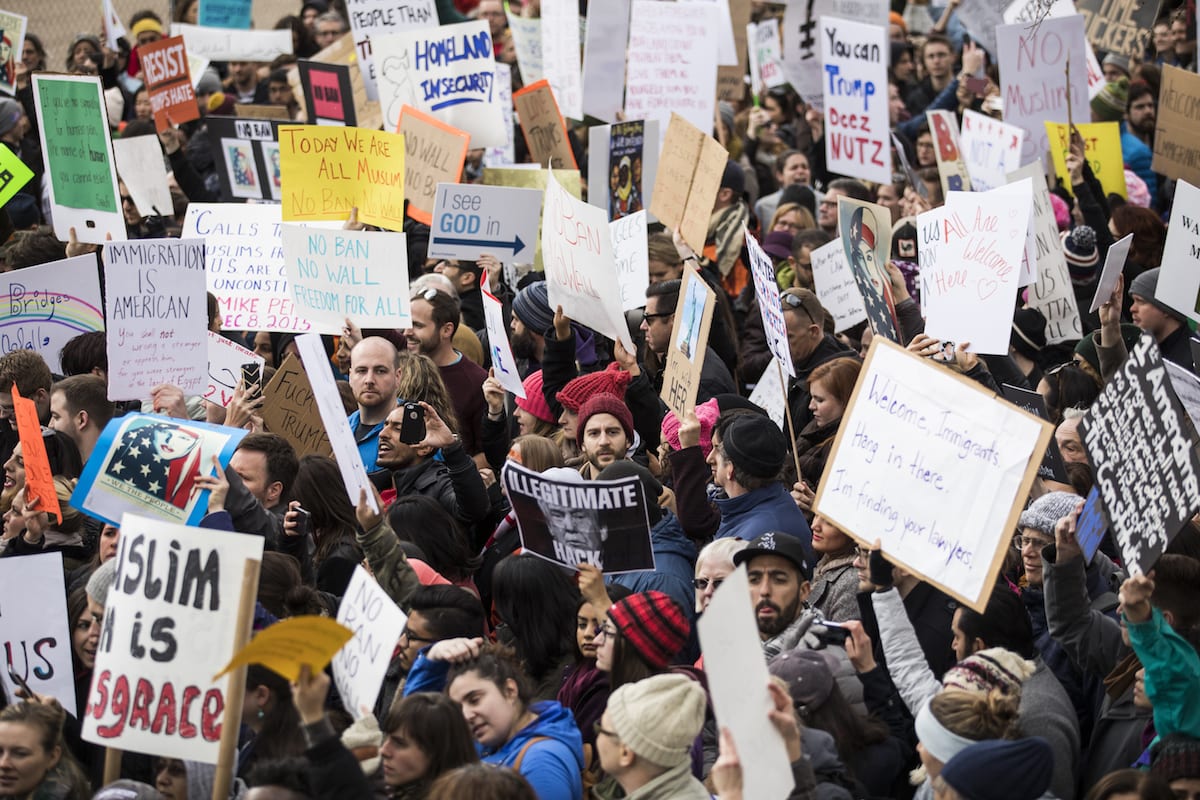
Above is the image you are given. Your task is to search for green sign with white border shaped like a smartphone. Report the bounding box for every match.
[32,72,126,245]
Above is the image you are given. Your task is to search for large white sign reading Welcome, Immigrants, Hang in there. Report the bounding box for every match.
[814,337,1054,612]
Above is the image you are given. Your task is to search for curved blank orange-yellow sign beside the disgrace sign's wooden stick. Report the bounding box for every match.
[212,616,354,680]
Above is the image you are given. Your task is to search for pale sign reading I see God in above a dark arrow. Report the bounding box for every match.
[428,183,541,263]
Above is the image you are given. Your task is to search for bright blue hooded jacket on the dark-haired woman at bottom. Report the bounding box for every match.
[482,700,583,800]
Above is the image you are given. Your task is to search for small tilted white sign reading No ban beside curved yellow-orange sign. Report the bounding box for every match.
[334,566,408,720]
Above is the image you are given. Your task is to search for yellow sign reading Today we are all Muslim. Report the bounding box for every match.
[280,125,404,230]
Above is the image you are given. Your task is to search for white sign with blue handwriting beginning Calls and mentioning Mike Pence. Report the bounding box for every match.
[182,203,312,333]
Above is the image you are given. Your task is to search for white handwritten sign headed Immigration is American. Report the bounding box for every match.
[103,239,209,401]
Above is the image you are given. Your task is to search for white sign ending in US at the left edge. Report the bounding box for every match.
[0,553,74,717]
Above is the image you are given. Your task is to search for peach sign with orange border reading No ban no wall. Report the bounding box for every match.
[396,106,470,225]
